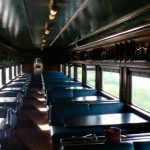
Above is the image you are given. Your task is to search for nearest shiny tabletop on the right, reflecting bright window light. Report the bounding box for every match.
[62,113,148,127]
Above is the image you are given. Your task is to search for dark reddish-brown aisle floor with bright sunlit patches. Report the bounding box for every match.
[6,70,57,150]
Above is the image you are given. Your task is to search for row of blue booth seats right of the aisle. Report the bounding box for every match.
[42,71,124,140]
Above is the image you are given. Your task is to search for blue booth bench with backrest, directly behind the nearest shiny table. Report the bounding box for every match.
[49,102,128,140]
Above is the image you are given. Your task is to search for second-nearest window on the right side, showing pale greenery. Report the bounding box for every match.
[102,71,119,97]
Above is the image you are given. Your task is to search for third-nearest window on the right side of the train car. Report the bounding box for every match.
[86,66,95,87]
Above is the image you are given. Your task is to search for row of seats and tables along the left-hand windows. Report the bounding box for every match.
[0,73,32,147]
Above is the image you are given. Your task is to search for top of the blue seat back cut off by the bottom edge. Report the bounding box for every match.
[60,140,150,150]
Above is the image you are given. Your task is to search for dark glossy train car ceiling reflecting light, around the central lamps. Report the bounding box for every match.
[0,0,150,53]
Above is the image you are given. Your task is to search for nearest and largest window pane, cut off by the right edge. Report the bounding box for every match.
[131,76,150,112]
